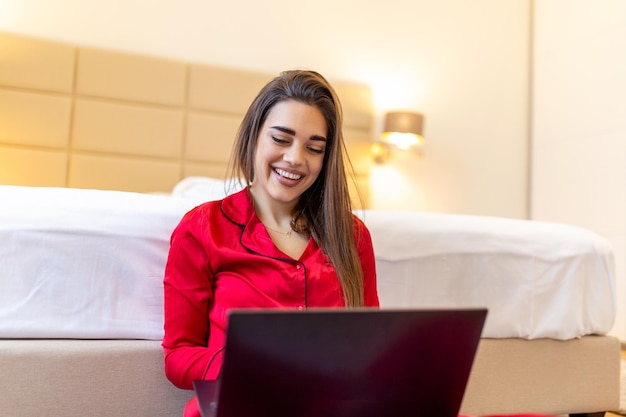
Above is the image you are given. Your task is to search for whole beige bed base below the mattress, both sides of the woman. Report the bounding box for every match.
[0,336,620,417]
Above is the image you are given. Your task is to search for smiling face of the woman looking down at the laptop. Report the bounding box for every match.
[251,100,327,205]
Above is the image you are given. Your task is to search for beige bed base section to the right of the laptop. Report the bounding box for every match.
[461,336,621,416]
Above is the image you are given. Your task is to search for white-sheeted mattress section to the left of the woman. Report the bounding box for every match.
[0,186,195,340]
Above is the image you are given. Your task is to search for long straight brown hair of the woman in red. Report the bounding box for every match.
[231,70,363,307]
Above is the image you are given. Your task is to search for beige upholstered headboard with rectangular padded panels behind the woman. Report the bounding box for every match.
[0,32,373,207]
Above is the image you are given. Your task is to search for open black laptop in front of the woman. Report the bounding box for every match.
[194,308,487,417]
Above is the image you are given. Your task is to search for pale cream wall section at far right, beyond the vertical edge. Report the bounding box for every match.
[532,0,626,340]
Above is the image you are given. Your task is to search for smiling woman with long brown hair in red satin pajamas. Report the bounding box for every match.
[163,70,378,416]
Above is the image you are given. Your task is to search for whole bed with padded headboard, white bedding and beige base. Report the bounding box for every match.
[0,33,620,417]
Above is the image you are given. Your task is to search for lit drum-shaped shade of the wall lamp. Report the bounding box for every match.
[382,112,424,149]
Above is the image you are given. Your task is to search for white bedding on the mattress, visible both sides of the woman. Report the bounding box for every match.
[0,186,615,340]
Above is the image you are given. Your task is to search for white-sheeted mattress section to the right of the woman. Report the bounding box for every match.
[362,211,616,340]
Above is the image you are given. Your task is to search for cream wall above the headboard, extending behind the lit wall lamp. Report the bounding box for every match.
[0,0,529,217]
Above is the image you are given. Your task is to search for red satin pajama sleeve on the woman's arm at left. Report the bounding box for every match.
[163,208,215,389]
